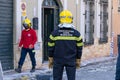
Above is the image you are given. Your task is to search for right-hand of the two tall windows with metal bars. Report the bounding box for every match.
[99,0,108,43]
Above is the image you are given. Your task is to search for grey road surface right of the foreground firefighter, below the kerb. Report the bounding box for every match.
[65,56,116,80]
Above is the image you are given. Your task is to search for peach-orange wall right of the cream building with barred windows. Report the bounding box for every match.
[112,0,120,54]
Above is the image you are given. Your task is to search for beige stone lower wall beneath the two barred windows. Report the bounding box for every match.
[82,39,110,60]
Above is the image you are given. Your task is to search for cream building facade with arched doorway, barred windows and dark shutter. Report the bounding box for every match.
[0,0,112,70]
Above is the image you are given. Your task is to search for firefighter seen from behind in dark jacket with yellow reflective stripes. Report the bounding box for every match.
[48,10,83,80]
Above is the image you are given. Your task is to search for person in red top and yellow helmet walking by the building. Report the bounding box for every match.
[15,18,37,73]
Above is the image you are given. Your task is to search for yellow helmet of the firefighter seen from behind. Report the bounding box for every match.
[59,10,73,23]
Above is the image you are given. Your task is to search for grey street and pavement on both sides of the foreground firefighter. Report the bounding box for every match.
[4,57,116,80]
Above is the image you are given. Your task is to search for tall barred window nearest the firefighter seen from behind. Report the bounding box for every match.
[84,0,95,45]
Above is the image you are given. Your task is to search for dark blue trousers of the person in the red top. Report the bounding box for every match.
[18,48,36,67]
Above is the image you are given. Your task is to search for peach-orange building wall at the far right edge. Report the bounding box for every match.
[112,0,120,55]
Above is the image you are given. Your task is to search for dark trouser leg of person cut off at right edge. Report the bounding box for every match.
[115,45,120,80]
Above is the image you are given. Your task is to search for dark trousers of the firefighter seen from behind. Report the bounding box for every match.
[53,62,76,80]
